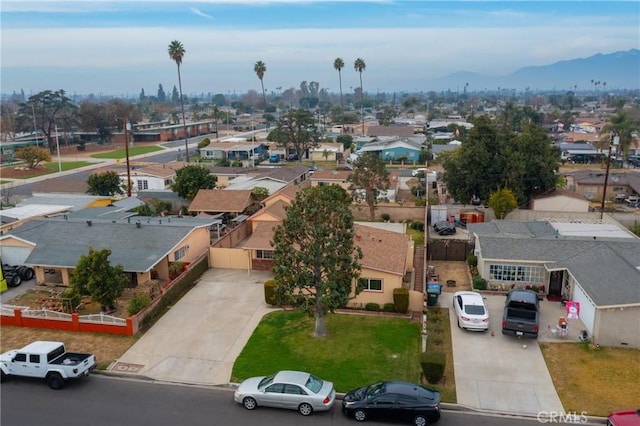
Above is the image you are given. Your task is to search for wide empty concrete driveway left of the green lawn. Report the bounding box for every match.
[109,269,273,385]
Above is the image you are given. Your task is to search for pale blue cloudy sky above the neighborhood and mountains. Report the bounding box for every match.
[0,0,640,96]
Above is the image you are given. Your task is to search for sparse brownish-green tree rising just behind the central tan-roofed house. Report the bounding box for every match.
[348,152,389,222]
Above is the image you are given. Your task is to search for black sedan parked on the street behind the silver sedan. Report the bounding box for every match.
[342,381,440,426]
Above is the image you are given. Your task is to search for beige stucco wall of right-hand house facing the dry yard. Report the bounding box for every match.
[593,306,640,348]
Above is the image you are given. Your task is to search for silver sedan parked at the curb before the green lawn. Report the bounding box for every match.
[233,370,336,416]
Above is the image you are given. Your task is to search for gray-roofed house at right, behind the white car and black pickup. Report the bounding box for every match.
[467,219,640,348]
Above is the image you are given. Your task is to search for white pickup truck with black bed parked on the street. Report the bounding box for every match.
[0,341,96,390]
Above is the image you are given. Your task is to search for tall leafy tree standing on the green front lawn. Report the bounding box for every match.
[271,185,362,337]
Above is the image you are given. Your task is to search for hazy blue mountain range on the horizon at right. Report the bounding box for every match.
[429,49,640,92]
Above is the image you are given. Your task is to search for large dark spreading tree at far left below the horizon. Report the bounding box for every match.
[18,90,77,152]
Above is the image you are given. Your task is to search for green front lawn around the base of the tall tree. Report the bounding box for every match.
[231,311,421,392]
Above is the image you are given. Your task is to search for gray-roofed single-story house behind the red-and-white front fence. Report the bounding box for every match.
[0,216,214,287]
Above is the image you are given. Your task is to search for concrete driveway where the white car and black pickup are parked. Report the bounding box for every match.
[439,293,564,415]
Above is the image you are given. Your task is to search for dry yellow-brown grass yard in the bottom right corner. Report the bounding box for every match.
[540,343,640,417]
